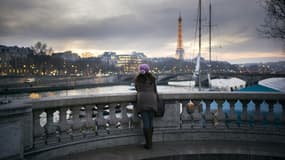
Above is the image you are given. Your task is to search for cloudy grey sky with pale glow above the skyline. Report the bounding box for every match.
[0,0,285,63]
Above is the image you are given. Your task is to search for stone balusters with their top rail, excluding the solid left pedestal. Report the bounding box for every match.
[30,92,285,148]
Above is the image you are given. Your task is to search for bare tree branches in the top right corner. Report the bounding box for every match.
[259,0,285,46]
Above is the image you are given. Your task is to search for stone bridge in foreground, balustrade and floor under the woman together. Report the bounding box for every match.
[0,92,285,160]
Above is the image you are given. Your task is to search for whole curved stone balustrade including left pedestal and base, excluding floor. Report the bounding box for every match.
[0,92,285,159]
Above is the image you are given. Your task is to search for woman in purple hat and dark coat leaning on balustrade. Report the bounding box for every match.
[135,64,158,149]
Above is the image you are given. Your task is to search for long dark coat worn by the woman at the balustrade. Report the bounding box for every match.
[135,74,158,112]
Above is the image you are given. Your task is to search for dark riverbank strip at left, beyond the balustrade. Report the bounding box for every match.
[0,76,130,95]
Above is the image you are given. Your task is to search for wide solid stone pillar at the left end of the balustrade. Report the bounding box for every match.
[0,103,33,159]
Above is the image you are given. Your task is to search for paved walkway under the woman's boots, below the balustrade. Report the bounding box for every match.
[53,141,285,160]
